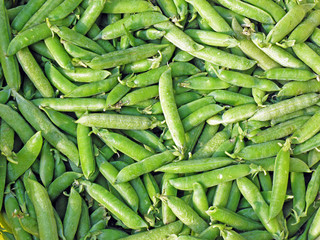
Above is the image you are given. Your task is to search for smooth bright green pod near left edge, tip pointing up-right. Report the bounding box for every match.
[8,132,42,181]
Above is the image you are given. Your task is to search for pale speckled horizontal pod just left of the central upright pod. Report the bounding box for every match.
[76,113,158,130]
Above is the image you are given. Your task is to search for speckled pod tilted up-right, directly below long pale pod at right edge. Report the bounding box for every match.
[249,116,310,143]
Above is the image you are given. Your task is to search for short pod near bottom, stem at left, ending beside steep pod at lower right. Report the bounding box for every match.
[207,206,264,231]
